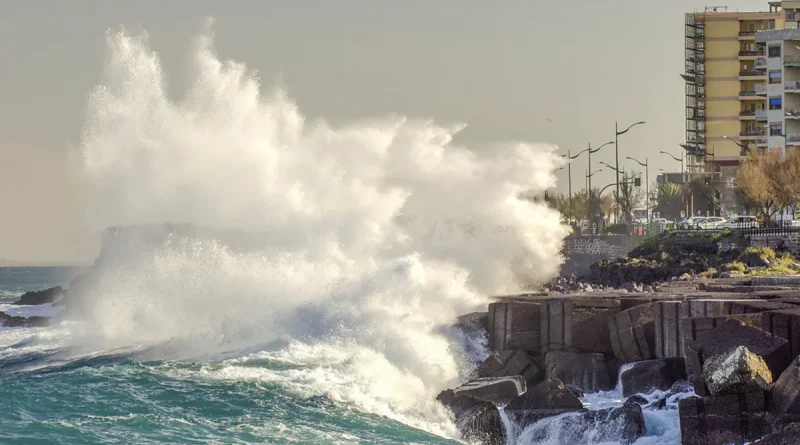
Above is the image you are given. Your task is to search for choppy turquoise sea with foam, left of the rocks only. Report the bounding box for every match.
[0,268,456,444]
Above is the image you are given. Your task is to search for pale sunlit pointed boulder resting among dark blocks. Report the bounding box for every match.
[703,346,772,396]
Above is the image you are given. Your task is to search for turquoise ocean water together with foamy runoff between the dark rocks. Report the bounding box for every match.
[0,268,692,445]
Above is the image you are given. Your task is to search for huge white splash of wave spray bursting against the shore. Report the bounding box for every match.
[72,26,566,433]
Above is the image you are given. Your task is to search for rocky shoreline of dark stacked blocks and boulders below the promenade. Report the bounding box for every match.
[438,278,800,445]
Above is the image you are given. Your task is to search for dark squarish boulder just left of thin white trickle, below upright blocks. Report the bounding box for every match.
[545,351,611,392]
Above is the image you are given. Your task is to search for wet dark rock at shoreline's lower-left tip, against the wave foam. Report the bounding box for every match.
[436,389,506,445]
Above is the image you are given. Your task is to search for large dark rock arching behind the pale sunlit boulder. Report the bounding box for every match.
[686,320,791,395]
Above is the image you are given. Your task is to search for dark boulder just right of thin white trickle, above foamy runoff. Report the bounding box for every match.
[620,357,687,397]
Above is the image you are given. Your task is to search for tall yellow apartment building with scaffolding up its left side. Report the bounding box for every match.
[682,0,780,212]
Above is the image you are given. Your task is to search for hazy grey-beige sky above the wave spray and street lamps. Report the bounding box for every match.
[0,0,767,261]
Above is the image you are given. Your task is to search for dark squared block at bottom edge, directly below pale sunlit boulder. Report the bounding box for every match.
[678,391,771,445]
